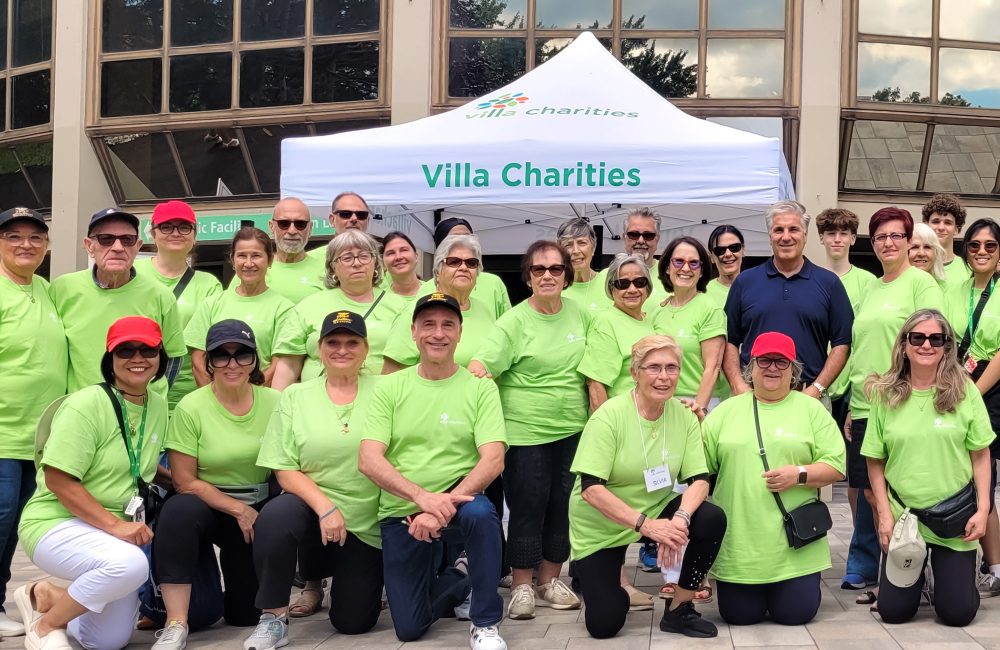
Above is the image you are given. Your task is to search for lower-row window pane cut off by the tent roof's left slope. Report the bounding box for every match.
[448,38,526,97]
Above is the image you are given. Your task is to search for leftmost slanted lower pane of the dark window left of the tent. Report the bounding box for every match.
[104,133,184,201]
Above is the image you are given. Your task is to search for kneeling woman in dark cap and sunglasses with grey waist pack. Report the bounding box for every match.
[153,320,280,650]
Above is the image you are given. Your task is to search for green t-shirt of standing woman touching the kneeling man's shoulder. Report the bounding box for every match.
[473,294,591,446]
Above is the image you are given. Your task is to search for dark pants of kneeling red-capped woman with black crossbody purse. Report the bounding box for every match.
[715,572,820,625]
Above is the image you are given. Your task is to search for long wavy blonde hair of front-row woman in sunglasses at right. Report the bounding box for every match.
[865,309,969,413]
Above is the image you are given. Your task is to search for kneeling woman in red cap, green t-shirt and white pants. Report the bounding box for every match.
[14,316,167,650]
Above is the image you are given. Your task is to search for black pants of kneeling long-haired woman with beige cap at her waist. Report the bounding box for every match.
[878,544,979,627]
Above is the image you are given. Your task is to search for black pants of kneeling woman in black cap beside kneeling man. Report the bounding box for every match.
[253,493,382,634]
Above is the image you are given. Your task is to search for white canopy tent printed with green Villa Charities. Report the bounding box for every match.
[281,32,794,254]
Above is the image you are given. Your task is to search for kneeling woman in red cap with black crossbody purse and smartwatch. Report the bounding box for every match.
[702,332,846,625]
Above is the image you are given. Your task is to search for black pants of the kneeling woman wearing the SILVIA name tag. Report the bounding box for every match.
[576,498,726,639]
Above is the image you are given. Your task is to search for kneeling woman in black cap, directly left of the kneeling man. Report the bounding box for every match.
[250,311,382,648]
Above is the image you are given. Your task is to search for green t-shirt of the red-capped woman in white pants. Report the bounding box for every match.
[18,386,167,557]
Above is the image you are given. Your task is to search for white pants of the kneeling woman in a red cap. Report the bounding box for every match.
[31,519,149,650]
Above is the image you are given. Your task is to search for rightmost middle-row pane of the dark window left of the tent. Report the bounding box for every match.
[312,41,379,104]
